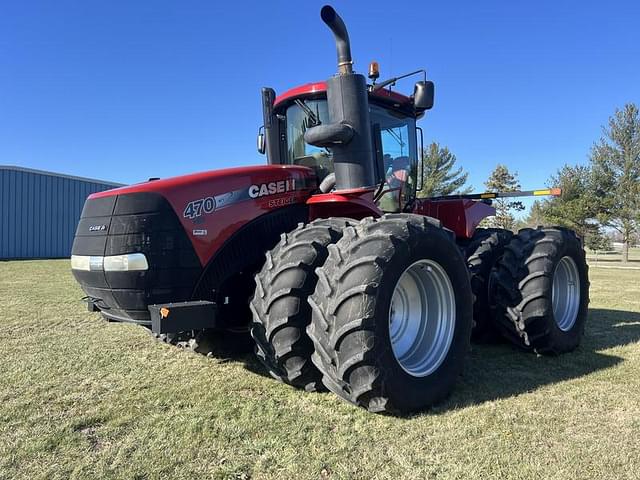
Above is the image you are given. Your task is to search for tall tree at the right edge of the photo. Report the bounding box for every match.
[591,103,640,262]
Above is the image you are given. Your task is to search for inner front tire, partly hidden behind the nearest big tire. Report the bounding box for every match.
[251,218,348,391]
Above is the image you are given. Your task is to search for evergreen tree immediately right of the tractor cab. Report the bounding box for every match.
[418,142,471,198]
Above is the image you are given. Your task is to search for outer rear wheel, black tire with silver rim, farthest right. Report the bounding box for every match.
[491,227,589,354]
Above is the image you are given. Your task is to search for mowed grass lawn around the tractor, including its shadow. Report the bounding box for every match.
[0,261,640,479]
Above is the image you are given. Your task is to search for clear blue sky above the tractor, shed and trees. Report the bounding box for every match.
[0,0,640,207]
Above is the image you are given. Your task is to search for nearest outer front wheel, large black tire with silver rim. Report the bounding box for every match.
[307,214,472,413]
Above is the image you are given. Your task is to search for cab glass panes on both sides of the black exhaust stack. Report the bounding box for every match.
[286,99,418,212]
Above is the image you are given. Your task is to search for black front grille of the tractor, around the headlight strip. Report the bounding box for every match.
[72,193,202,324]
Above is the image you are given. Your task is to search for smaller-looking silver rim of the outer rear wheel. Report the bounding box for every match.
[551,257,580,332]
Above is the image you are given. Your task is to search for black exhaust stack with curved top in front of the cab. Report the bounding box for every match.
[304,5,379,190]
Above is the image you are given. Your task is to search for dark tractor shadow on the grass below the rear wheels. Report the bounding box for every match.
[442,308,640,413]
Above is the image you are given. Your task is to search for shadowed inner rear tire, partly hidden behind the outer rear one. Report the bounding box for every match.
[465,228,513,343]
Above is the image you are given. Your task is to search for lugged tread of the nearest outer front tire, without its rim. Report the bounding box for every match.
[307,214,470,414]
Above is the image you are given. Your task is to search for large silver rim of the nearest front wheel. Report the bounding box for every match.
[389,260,456,377]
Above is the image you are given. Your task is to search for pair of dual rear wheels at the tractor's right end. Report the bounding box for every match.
[463,227,589,354]
